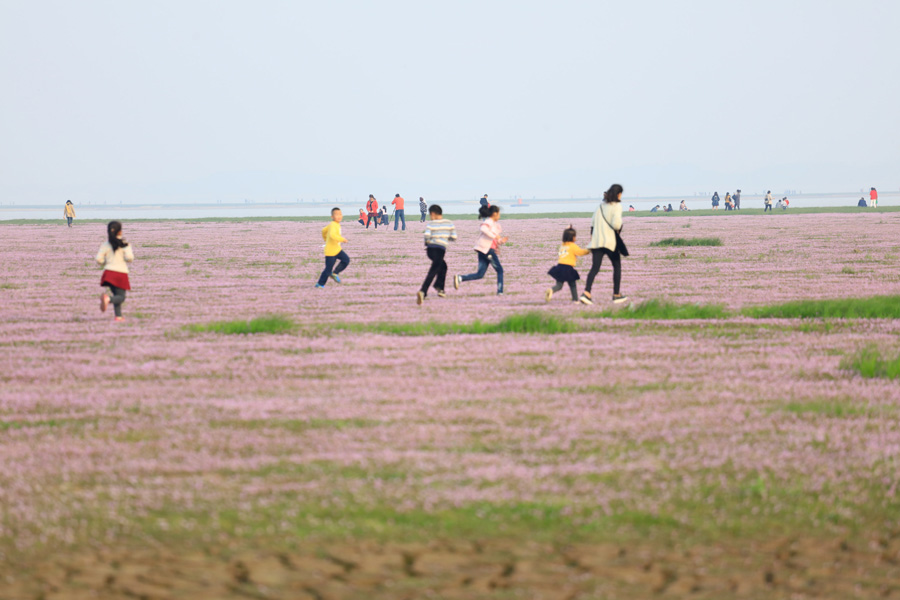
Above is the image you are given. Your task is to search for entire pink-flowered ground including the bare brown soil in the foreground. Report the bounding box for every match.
[0,213,900,599]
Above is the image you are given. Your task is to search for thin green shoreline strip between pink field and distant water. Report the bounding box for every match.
[0,205,900,226]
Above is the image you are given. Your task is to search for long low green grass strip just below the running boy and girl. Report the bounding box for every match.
[337,311,581,335]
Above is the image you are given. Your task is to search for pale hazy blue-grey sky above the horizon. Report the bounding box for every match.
[0,0,900,204]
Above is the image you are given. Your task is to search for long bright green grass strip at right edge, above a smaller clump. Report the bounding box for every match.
[741,296,900,319]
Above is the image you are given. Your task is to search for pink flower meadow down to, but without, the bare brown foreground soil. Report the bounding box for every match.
[0,213,900,548]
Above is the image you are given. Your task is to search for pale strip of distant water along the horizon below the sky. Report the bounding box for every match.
[0,193,884,221]
